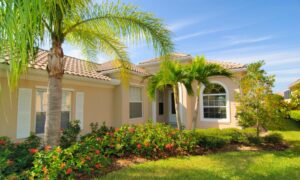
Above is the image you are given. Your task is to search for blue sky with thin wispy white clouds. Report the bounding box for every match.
[50,0,300,92]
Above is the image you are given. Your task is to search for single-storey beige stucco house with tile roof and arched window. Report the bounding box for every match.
[0,49,245,140]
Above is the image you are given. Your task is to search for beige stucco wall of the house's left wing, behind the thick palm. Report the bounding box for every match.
[0,68,151,140]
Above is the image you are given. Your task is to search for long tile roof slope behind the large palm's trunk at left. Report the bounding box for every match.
[0,49,111,81]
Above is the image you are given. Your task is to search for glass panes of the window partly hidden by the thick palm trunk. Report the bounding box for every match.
[35,89,72,134]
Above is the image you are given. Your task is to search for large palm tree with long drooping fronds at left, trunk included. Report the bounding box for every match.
[0,0,173,146]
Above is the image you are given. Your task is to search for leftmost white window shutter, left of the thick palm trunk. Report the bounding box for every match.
[17,88,32,139]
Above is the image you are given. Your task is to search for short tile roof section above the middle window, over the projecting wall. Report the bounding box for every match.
[98,61,149,75]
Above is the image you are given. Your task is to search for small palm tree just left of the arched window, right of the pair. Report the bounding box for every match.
[188,56,232,129]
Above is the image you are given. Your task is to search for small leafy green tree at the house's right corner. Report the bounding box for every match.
[236,61,276,137]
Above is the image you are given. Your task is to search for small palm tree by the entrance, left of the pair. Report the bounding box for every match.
[147,60,193,130]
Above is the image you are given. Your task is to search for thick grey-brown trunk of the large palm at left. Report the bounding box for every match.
[44,42,65,146]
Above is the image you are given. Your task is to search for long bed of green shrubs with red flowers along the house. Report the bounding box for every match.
[0,123,260,179]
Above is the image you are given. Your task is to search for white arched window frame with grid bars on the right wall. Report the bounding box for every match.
[199,81,231,123]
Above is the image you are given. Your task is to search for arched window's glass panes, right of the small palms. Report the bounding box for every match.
[203,84,227,120]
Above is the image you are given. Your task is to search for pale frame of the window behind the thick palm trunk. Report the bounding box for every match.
[33,86,75,137]
